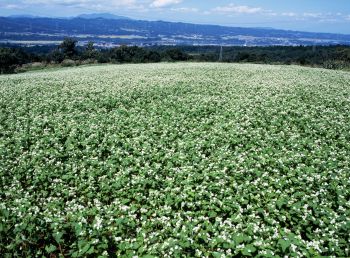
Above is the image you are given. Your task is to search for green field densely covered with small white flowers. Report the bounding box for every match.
[0,63,350,257]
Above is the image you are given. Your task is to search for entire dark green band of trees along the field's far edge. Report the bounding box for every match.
[0,38,350,73]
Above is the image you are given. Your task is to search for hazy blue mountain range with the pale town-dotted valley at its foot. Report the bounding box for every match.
[0,13,350,47]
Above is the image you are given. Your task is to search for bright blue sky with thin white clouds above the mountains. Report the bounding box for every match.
[0,0,350,34]
